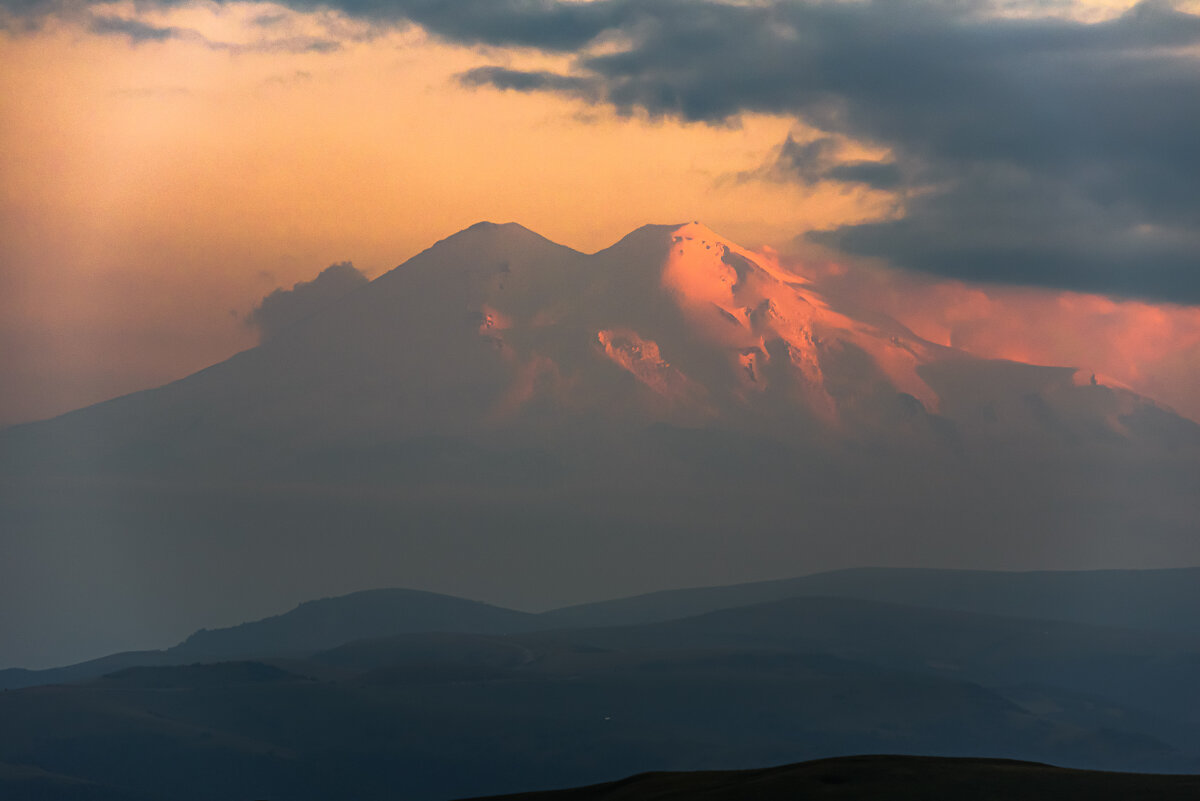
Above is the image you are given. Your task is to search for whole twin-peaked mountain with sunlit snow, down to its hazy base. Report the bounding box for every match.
[0,223,1200,661]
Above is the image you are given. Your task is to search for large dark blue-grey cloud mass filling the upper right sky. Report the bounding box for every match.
[448,0,1200,302]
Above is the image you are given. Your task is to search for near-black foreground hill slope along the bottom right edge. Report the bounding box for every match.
[456,757,1200,801]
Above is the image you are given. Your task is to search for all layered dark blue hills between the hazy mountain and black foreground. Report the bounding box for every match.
[0,568,1200,801]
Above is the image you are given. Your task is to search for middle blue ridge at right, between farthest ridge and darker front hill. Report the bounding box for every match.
[540,597,1200,727]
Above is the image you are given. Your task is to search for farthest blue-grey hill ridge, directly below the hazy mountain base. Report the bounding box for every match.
[9,568,1200,688]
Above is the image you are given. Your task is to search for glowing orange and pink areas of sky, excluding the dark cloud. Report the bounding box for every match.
[0,4,1200,424]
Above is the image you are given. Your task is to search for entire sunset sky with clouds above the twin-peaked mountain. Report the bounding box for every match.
[0,0,1200,424]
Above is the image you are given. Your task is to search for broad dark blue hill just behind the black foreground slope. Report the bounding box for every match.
[0,643,1180,801]
